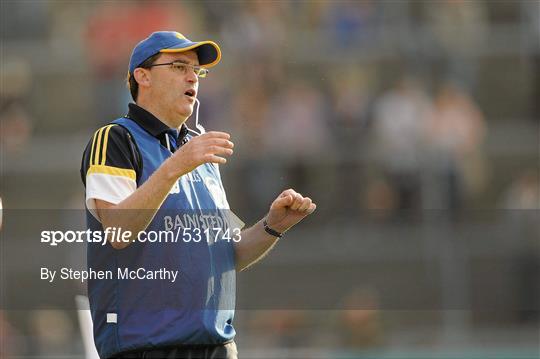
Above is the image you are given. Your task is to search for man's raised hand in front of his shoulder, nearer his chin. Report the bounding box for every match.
[167,131,234,177]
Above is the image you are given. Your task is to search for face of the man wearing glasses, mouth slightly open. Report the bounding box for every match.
[146,50,199,125]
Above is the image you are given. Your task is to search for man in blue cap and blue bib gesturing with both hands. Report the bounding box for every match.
[81,31,316,358]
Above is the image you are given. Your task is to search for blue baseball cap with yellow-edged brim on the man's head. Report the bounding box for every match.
[129,31,221,74]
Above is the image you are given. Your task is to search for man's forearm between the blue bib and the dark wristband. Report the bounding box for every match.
[234,219,278,272]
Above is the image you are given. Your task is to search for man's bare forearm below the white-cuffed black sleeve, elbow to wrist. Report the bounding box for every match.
[98,162,179,249]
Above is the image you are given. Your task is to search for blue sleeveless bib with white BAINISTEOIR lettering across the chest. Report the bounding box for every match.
[87,118,239,358]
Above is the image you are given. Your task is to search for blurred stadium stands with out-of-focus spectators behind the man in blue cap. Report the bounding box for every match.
[0,0,540,358]
